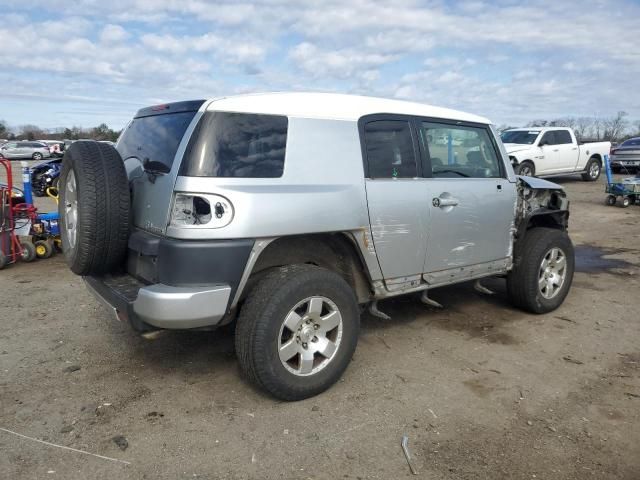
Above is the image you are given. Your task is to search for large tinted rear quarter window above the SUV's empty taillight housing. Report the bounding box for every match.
[180,112,288,178]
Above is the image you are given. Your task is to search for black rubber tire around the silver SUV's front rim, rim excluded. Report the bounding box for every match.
[507,228,575,313]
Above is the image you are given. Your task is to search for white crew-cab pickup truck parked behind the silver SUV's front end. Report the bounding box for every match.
[501,127,611,182]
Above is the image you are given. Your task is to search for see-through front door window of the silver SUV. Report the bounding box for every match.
[420,122,501,178]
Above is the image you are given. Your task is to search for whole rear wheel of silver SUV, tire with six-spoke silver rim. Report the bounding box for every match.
[235,265,360,401]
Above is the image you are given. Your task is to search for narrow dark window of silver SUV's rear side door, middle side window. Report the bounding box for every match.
[364,120,418,178]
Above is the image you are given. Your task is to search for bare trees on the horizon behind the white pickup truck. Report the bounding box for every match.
[498,111,640,142]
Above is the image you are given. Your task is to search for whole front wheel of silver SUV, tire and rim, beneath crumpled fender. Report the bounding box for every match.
[507,228,575,313]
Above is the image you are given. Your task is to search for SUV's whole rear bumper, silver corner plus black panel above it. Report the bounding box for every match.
[84,231,254,331]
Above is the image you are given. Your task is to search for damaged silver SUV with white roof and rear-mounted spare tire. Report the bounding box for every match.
[60,93,574,400]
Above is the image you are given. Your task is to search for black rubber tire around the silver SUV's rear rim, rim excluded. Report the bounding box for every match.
[235,265,360,401]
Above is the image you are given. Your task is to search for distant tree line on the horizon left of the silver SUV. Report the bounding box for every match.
[0,120,122,142]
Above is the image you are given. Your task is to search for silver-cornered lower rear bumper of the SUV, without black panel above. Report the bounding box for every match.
[84,274,231,331]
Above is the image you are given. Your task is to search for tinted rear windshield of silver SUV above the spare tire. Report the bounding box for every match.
[118,112,196,172]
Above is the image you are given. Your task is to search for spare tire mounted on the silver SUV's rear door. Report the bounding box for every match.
[58,141,131,275]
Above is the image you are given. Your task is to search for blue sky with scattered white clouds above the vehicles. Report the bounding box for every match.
[0,0,640,128]
